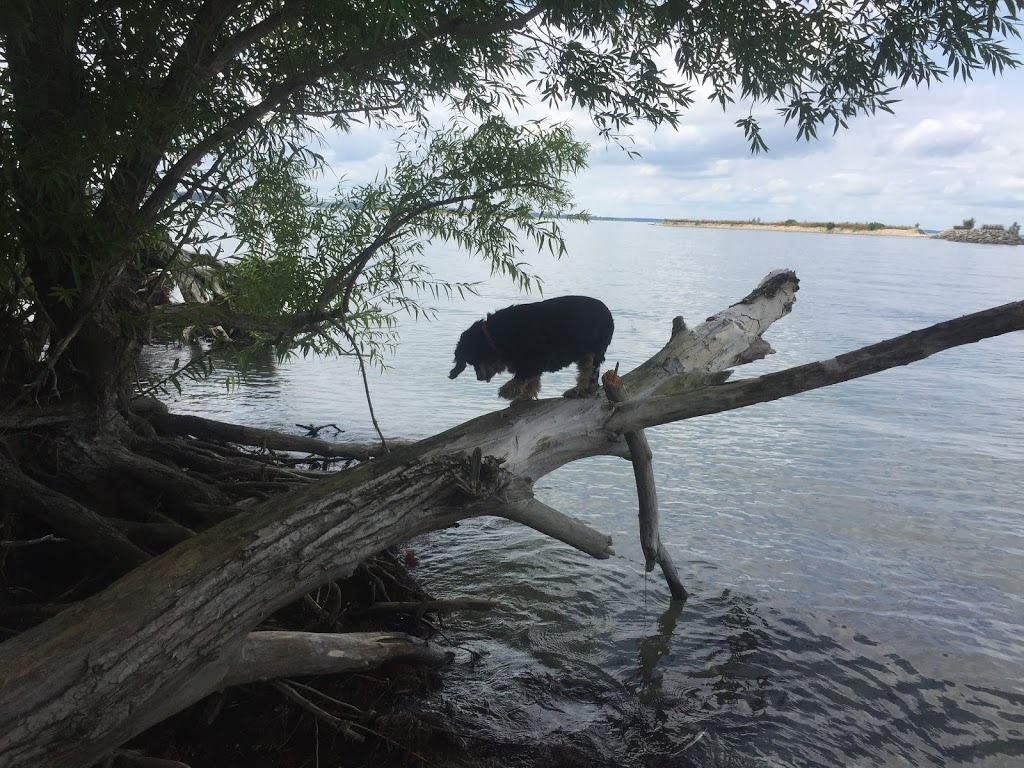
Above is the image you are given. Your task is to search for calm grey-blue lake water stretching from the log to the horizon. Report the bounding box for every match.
[153,221,1024,767]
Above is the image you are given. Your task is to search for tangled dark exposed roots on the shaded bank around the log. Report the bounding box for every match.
[0,421,468,768]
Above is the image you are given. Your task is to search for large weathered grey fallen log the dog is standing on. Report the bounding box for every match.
[0,272,1024,768]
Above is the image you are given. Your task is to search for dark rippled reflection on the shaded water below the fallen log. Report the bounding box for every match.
[422,521,1024,768]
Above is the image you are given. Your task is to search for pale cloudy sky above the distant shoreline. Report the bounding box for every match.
[325,53,1024,229]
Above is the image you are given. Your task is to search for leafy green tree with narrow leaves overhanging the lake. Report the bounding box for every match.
[0,0,1019,407]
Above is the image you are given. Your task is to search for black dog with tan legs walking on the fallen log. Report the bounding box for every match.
[449,296,615,400]
